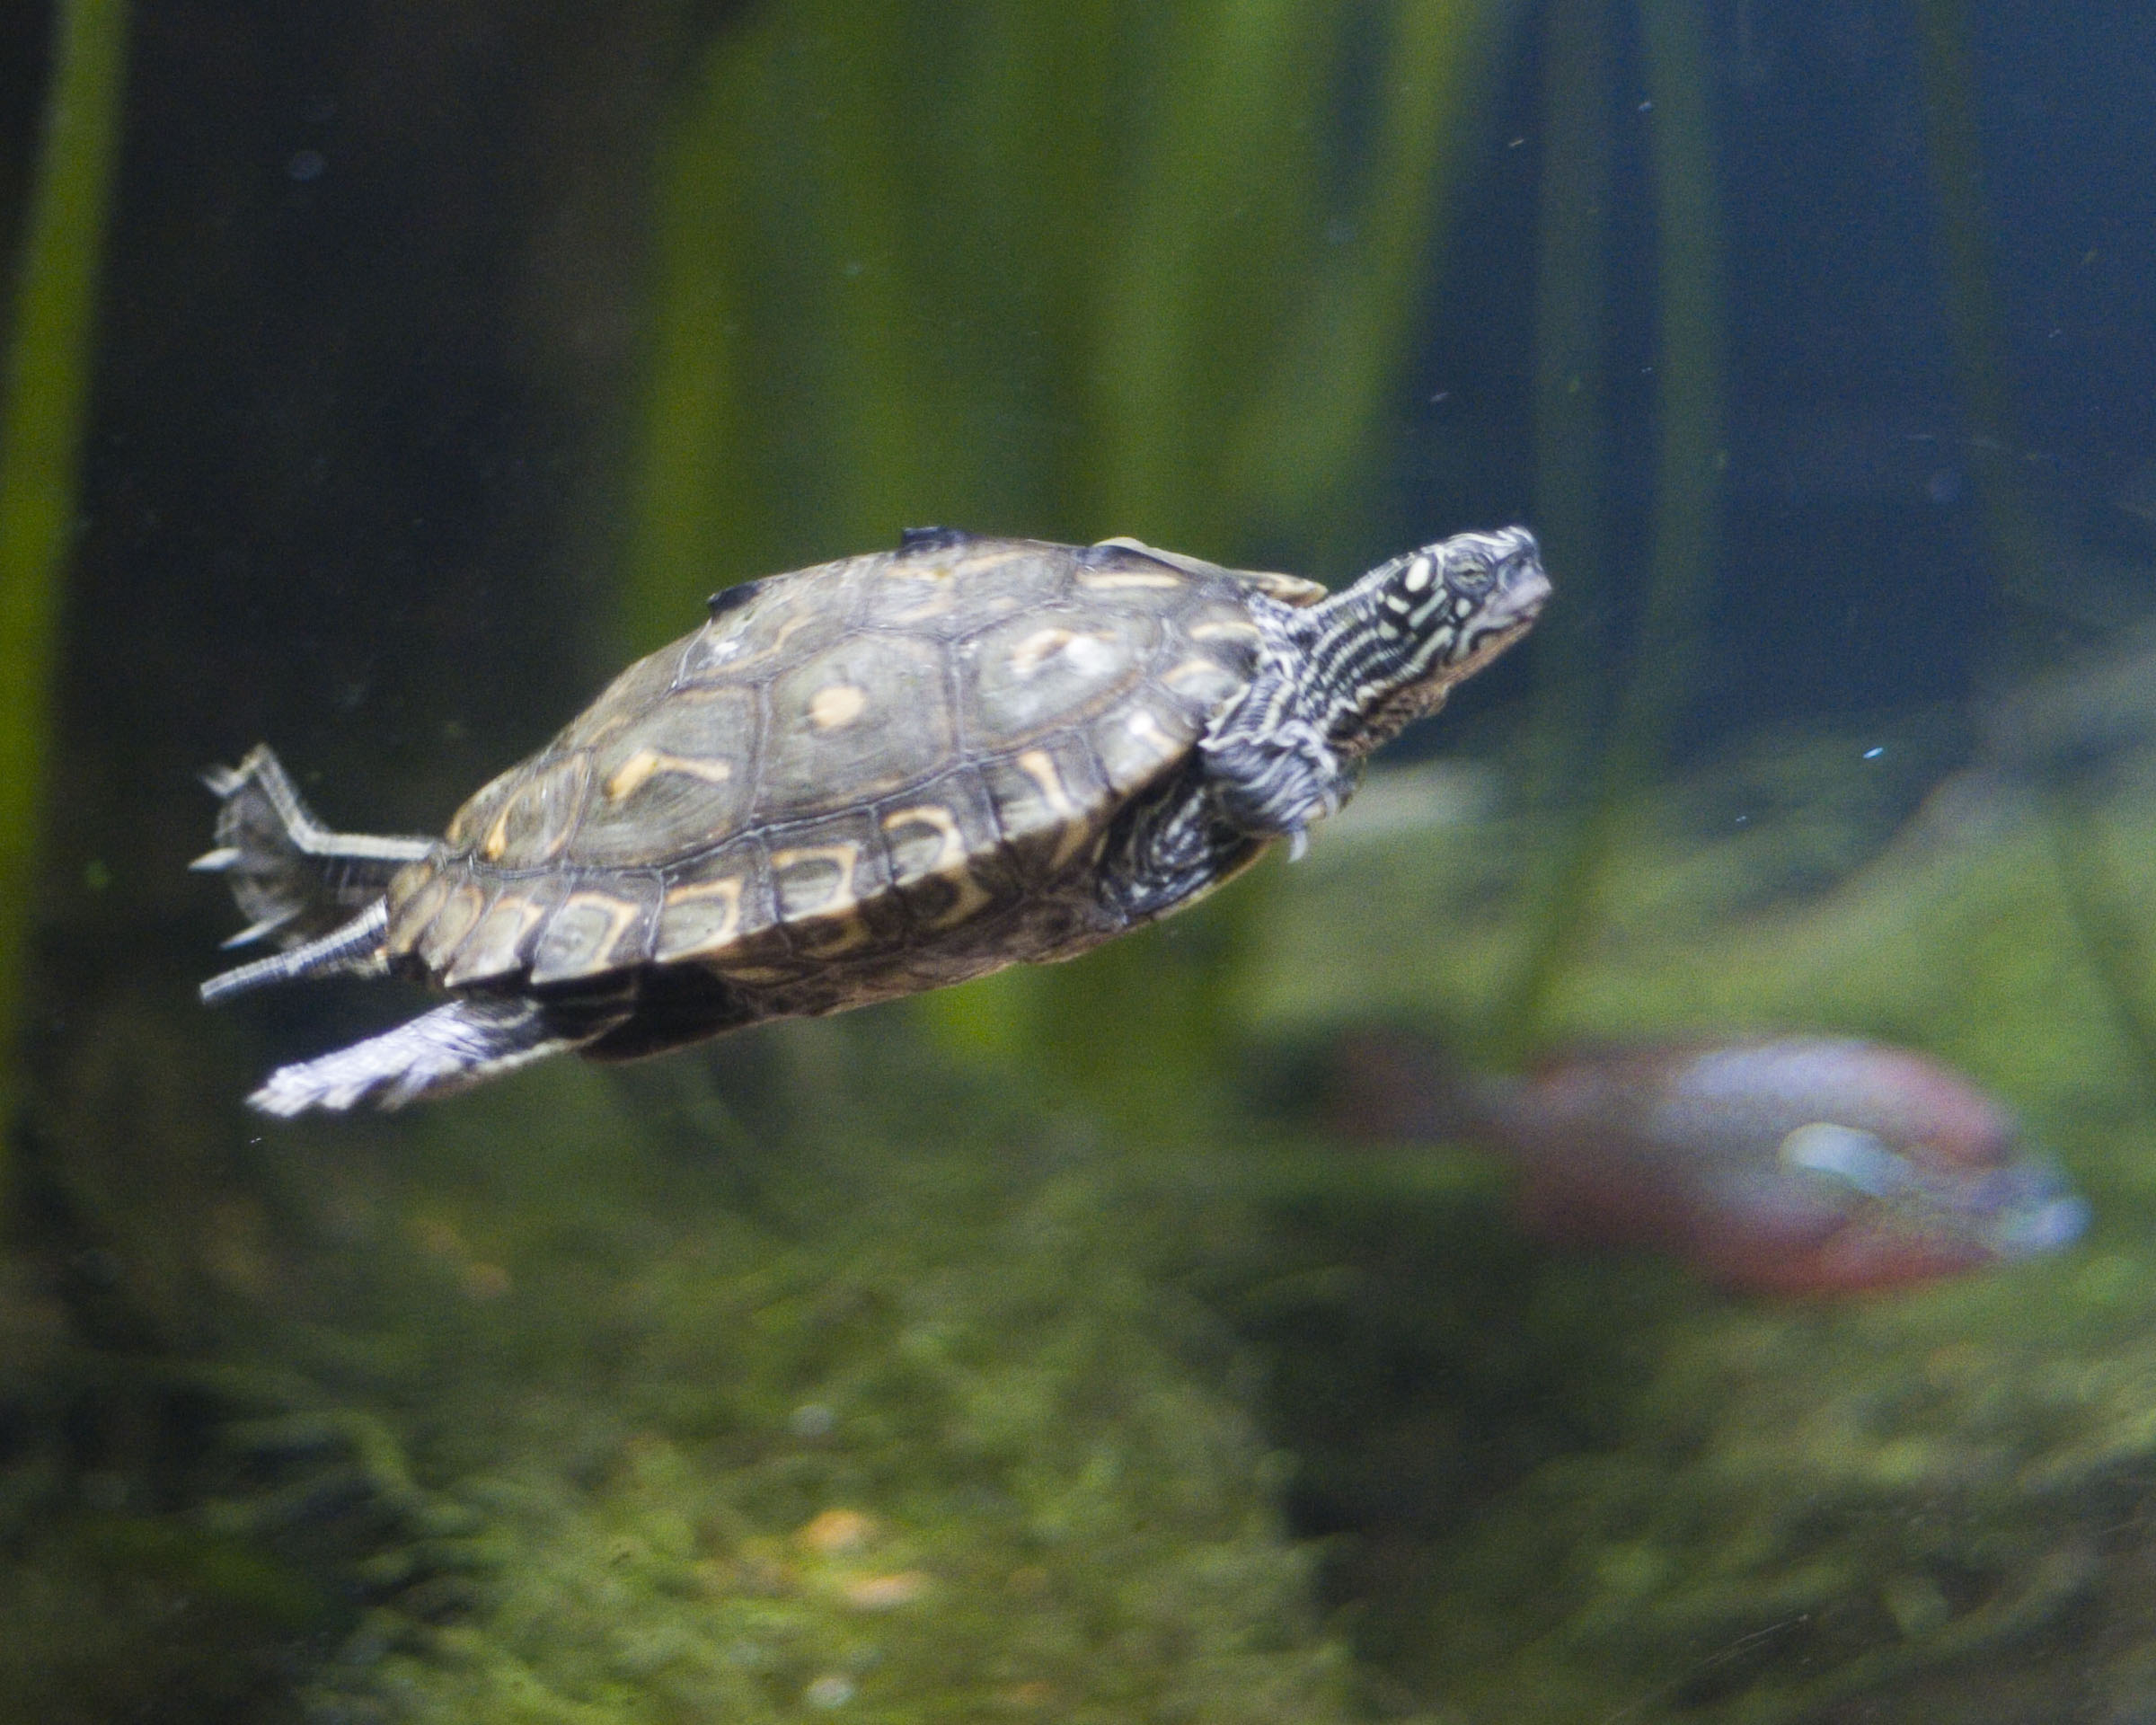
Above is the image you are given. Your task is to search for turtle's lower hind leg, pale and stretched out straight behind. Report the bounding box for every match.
[248,994,627,1119]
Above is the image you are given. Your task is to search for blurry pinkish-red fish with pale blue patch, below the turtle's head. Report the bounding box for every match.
[1339,1037,2090,1294]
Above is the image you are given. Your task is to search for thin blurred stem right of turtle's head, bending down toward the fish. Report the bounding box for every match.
[1503,0,1723,1052]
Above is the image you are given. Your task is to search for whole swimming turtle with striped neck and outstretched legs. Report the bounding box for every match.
[194,528,1551,1115]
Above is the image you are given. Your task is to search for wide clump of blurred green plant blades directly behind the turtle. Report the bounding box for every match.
[623,0,1518,1137]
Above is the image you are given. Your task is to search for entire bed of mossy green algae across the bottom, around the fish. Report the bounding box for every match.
[25,694,2156,1725]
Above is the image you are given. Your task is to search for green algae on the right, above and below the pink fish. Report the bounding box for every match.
[1259,698,2156,1725]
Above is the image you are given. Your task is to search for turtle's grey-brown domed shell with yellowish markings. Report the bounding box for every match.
[388,530,1324,1009]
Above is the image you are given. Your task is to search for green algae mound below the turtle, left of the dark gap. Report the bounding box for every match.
[97,1026,1341,1721]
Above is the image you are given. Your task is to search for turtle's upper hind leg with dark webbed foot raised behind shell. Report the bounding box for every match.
[194,744,433,947]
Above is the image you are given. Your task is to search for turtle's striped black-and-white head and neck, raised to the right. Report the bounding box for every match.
[1304,526,1551,755]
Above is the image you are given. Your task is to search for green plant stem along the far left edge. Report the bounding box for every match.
[0,0,128,1206]
